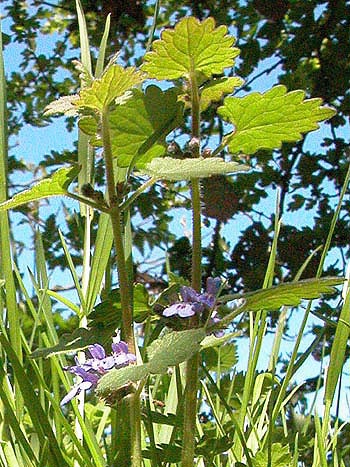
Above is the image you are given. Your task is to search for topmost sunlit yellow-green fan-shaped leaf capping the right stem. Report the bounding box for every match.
[141,16,239,79]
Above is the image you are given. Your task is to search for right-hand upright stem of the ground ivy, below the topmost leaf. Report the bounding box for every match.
[181,67,202,467]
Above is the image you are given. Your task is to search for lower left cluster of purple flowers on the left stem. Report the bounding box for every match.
[61,341,136,406]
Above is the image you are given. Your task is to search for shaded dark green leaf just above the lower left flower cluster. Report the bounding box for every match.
[31,326,115,358]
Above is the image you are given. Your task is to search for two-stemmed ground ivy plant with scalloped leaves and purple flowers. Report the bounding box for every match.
[0,13,341,467]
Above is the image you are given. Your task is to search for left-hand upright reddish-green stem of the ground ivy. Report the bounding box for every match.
[101,109,142,467]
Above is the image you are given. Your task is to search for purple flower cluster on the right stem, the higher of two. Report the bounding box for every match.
[163,277,221,330]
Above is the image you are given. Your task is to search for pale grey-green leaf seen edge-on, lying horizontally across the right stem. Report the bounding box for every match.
[140,157,250,181]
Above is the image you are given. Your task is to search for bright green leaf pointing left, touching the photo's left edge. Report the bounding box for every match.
[0,166,80,211]
